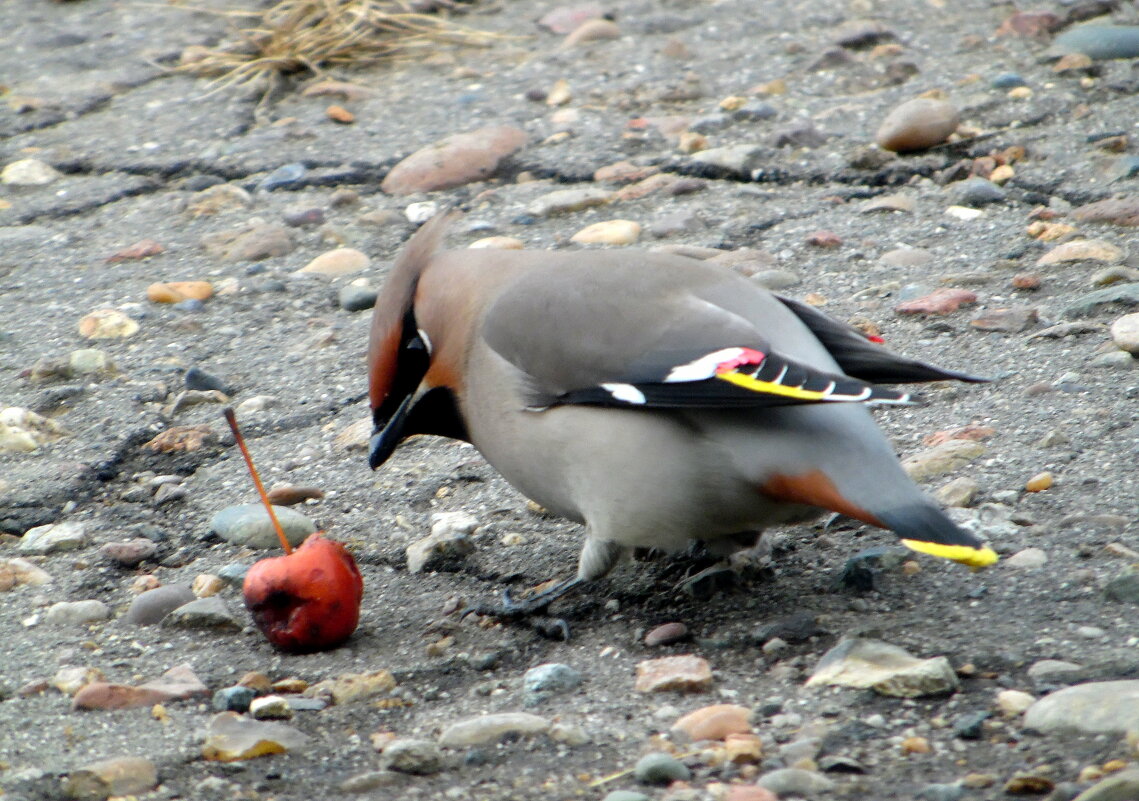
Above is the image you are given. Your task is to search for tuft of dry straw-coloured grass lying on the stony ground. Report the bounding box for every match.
[177,0,497,91]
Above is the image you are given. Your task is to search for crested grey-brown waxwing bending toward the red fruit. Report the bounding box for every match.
[367,213,998,614]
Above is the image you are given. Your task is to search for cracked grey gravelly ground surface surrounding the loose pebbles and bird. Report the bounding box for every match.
[0,0,1139,799]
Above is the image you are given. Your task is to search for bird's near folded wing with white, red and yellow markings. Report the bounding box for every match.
[482,266,910,408]
